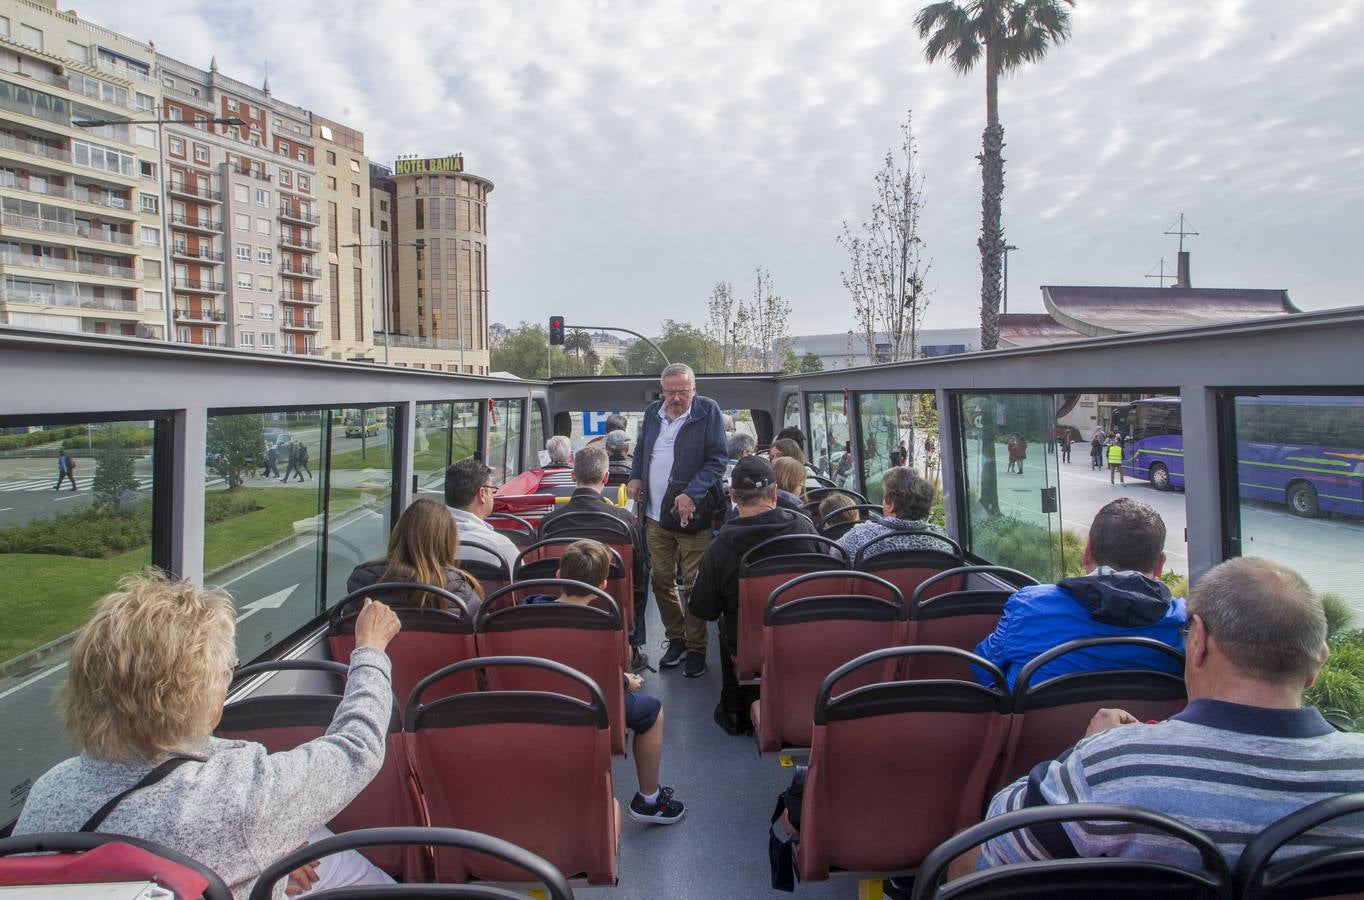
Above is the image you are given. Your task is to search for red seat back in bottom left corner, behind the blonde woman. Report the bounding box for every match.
[0,832,232,900]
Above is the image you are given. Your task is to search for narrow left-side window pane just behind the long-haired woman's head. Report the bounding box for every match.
[325,406,397,605]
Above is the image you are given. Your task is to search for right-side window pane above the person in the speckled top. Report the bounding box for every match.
[858,393,944,510]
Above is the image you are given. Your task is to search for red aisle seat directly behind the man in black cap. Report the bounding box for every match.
[735,535,848,680]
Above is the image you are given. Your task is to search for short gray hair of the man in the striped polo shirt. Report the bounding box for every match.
[1188,556,1326,686]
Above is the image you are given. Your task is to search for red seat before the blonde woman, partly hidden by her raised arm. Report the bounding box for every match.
[214,660,427,881]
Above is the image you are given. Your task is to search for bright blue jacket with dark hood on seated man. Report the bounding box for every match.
[975,570,1188,687]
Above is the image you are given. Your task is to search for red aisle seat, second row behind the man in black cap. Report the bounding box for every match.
[752,571,908,753]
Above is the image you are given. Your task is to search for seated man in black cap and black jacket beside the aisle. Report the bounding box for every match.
[690,457,820,735]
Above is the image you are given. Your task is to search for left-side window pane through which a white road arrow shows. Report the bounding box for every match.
[203,409,324,661]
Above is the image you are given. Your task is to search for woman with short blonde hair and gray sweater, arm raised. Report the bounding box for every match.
[14,574,400,900]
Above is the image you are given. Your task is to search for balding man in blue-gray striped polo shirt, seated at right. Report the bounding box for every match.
[981,558,1364,867]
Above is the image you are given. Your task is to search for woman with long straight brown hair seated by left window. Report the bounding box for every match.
[345,498,483,614]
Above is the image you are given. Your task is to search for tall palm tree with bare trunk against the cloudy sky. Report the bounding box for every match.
[914,0,1075,350]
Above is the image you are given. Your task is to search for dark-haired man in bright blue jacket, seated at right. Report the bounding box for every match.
[975,498,1188,686]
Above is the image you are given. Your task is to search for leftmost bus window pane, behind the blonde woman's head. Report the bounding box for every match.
[0,421,155,826]
